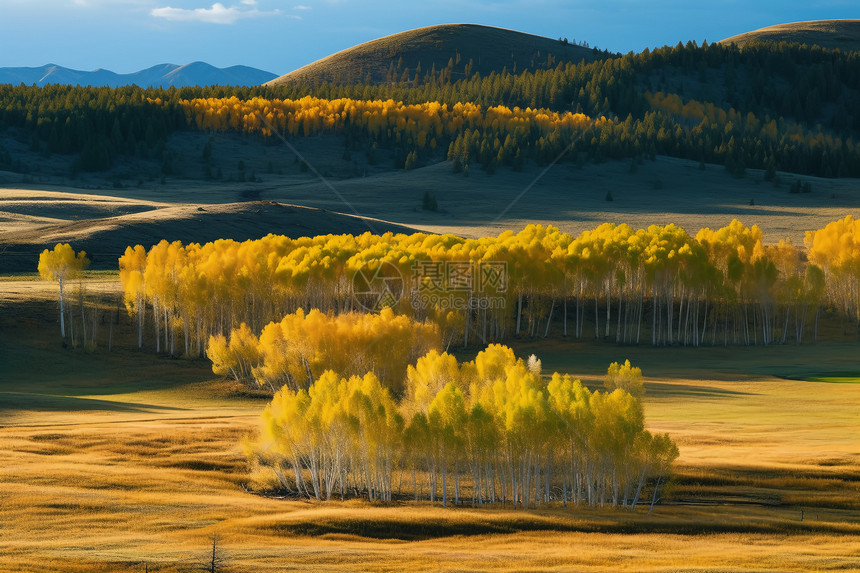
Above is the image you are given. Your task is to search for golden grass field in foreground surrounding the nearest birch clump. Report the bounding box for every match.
[0,284,860,571]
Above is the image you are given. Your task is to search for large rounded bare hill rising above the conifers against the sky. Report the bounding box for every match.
[269,24,608,85]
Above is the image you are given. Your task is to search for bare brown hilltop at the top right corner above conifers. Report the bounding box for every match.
[720,20,860,52]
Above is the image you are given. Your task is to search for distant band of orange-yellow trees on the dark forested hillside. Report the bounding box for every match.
[179,96,611,168]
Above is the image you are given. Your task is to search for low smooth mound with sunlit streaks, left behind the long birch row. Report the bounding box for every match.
[0,189,416,274]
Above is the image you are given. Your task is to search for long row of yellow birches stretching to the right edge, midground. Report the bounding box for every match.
[119,216,860,356]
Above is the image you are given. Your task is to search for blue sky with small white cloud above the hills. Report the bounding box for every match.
[0,0,860,74]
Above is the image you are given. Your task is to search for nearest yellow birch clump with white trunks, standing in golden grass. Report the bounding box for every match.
[247,345,678,509]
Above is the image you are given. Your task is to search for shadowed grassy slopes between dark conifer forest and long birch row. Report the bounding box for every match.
[6,130,860,273]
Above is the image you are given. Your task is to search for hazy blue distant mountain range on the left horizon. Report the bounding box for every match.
[0,62,278,88]
